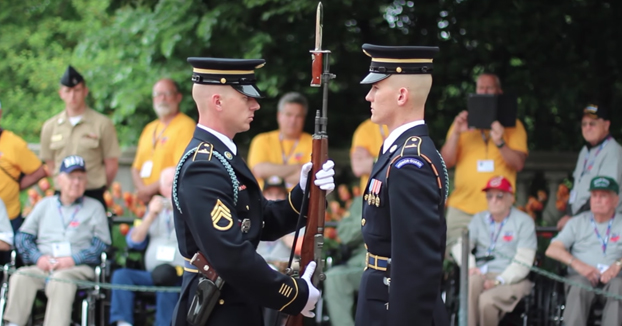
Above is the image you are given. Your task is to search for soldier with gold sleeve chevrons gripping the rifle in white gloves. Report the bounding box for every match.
[173,58,335,326]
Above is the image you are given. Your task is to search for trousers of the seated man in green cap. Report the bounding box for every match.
[564,275,622,326]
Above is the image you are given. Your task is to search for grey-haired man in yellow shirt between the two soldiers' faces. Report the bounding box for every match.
[248,92,313,190]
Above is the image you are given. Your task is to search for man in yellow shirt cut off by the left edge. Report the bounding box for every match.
[0,104,46,264]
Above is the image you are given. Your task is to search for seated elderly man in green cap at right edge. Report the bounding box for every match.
[546,176,622,326]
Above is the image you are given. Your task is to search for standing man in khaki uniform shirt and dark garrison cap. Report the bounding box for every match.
[40,66,121,207]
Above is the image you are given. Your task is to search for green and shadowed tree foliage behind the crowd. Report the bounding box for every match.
[0,0,622,154]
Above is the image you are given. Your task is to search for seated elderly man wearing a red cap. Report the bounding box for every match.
[452,177,537,326]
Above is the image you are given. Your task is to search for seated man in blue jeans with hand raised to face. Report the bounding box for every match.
[110,167,184,326]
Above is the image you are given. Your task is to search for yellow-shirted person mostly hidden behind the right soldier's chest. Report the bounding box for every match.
[350,119,389,191]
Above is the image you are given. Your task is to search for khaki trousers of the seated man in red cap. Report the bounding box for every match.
[468,273,532,326]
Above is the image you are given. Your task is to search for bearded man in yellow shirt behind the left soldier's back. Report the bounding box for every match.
[132,79,196,203]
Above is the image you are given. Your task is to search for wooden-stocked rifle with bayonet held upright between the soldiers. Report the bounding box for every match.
[286,2,335,326]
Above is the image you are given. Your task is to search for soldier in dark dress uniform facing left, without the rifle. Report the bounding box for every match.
[356,44,449,326]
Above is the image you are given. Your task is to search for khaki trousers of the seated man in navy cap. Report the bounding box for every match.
[4,265,95,326]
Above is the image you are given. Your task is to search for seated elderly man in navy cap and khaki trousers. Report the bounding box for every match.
[4,156,110,326]
